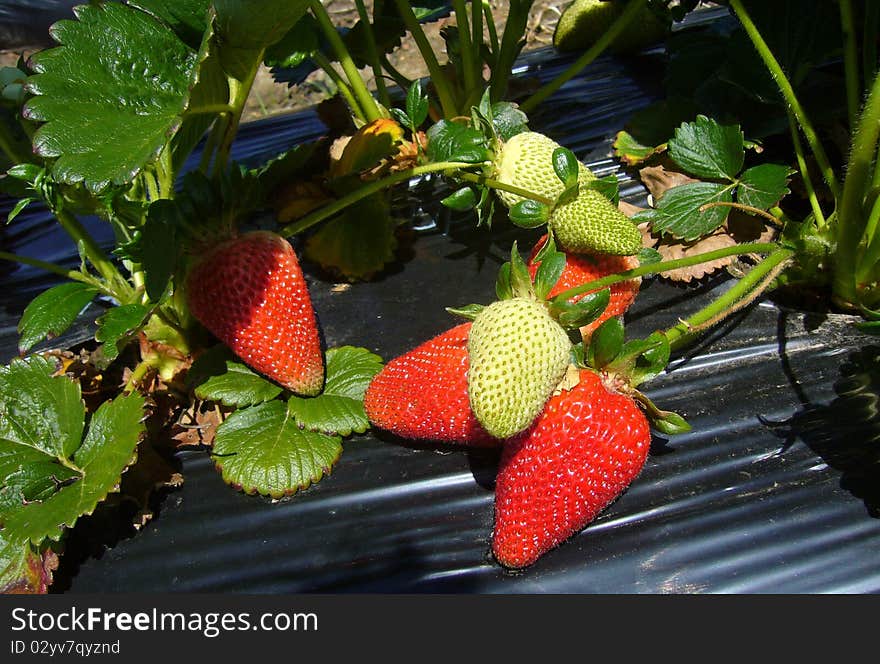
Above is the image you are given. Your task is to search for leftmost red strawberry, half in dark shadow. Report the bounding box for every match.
[186,231,324,396]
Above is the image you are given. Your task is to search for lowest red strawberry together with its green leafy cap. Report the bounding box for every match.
[492,318,690,568]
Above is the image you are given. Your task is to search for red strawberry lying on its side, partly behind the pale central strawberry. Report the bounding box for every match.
[364,323,501,446]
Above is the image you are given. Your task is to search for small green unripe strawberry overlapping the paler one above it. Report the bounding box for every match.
[547,187,642,256]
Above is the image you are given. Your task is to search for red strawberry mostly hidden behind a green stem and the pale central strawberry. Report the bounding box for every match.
[528,235,642,339]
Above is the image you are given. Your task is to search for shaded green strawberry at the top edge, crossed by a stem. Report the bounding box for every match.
[553,0,667,53]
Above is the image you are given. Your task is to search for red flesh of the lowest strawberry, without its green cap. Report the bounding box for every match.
[492,369,651,568]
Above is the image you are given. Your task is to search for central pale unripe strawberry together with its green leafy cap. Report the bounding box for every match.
[450,244,608,438]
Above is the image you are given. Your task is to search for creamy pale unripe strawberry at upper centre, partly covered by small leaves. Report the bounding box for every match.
[495,131,595,208]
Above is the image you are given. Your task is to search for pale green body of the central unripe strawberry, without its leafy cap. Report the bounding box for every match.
[468,297,571,438]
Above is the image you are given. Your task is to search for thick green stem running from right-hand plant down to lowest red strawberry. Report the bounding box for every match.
[665,247,794,350]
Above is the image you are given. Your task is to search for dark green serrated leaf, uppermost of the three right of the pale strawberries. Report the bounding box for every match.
[669,115,745,180]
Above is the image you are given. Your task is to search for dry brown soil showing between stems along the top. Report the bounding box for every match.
[0,0,571,122]
